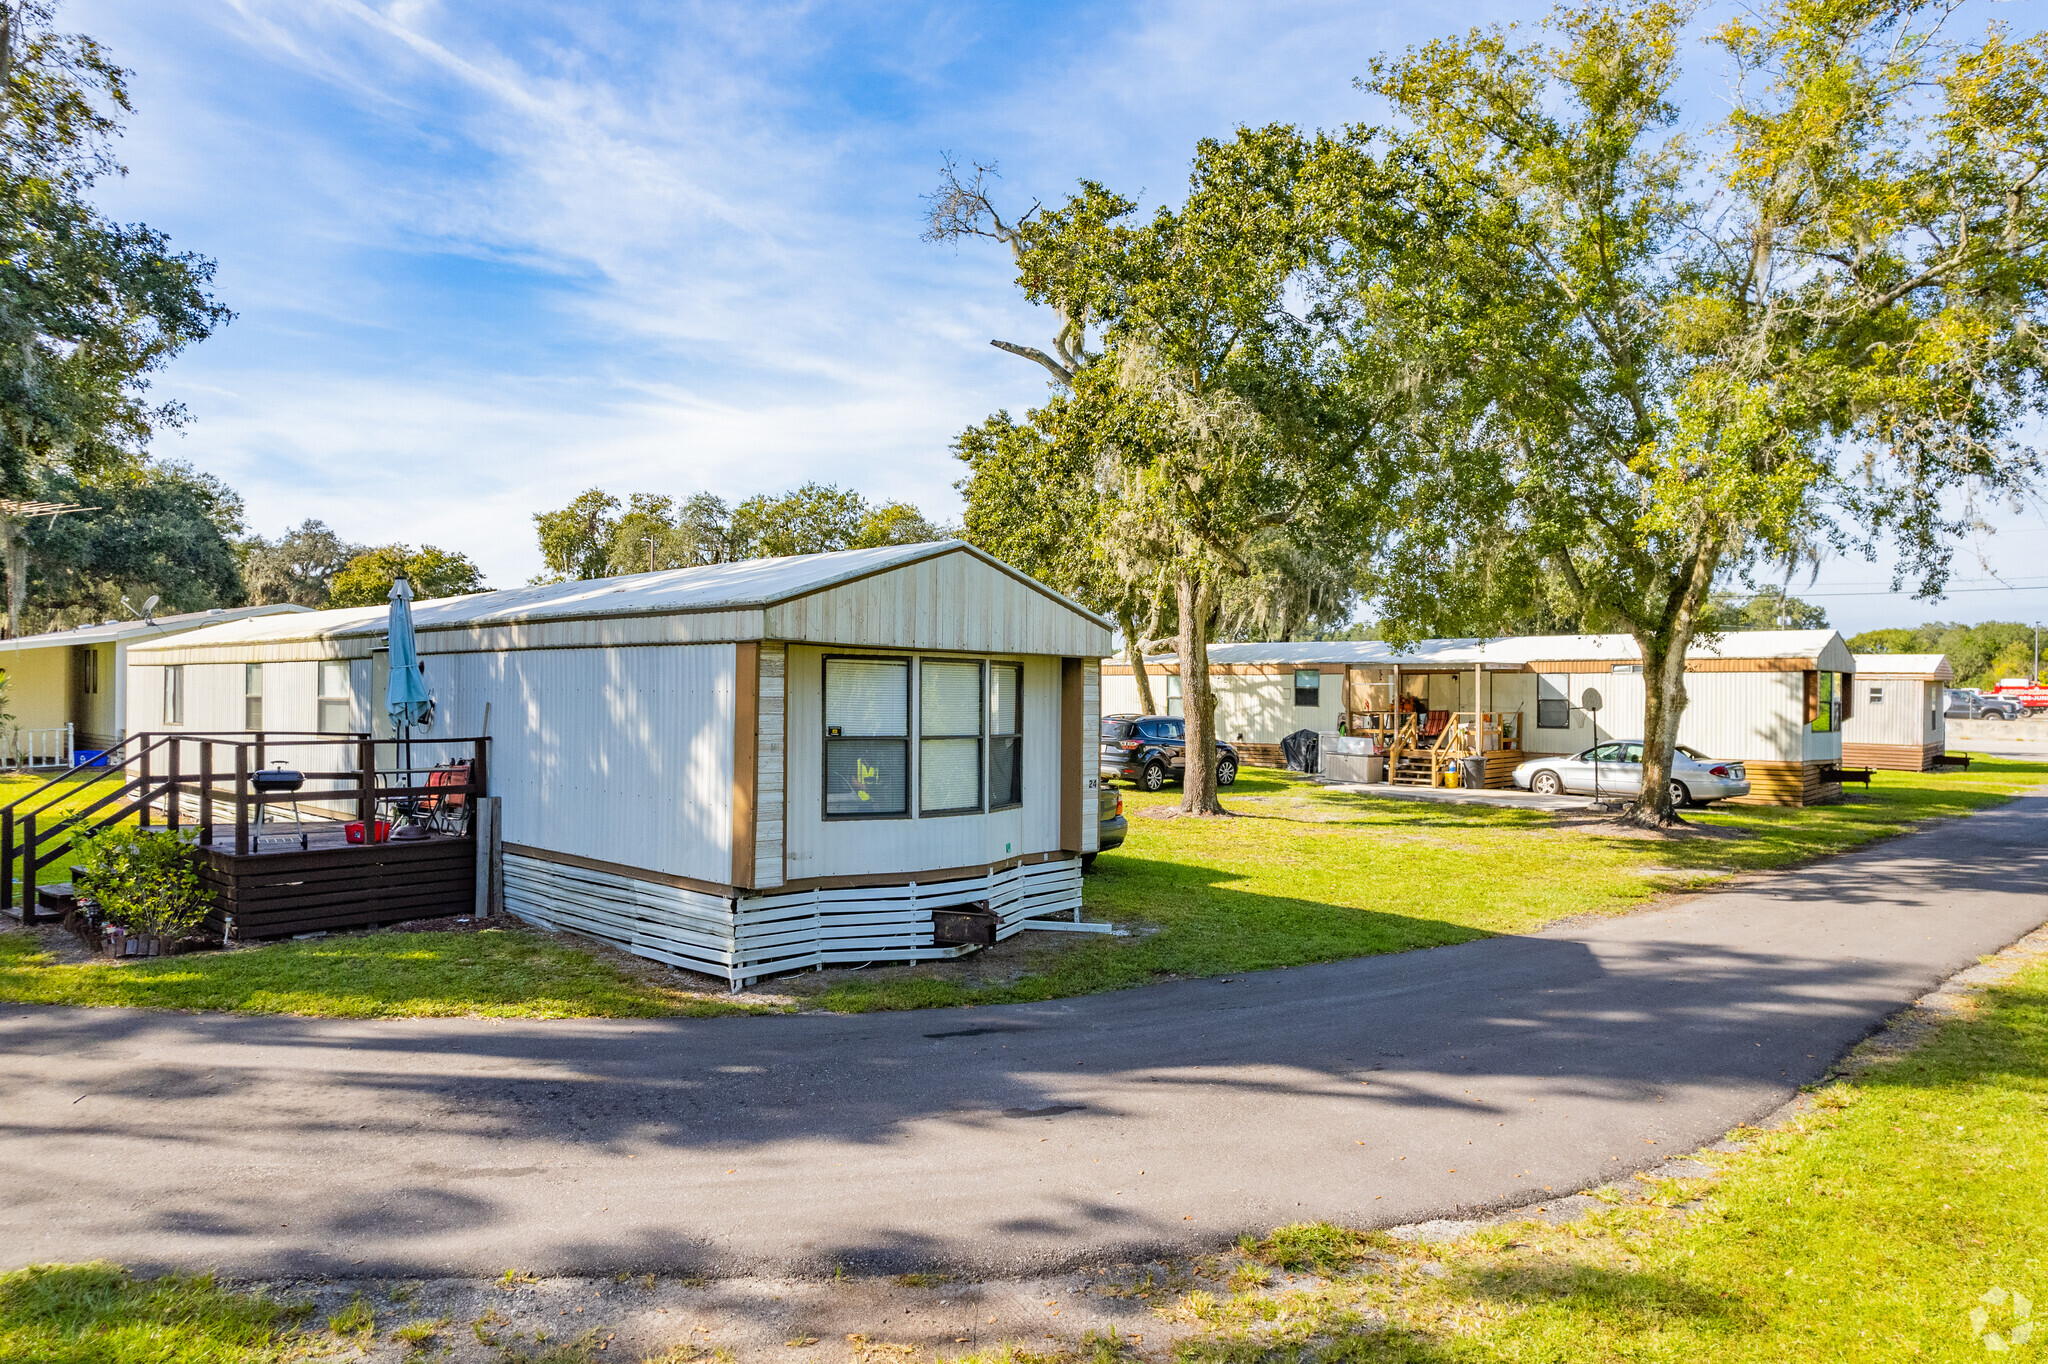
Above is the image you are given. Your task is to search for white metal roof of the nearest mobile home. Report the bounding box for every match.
[119,541,1112,647]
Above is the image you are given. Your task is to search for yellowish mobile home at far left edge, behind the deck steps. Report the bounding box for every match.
[0,604,305,766]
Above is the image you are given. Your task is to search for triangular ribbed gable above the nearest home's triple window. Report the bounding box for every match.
[764,555,1110,657]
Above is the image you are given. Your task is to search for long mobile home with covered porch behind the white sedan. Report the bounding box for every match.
[1102,631,1855,805]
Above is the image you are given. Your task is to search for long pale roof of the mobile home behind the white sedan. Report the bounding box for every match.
[1116,631,1853,672]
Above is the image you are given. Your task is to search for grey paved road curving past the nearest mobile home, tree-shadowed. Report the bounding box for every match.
[0,782,2048,1274]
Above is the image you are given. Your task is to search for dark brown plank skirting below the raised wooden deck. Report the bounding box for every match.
[197,821,477,940]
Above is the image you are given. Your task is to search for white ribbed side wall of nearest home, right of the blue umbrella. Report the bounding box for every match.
[428,643,735,885]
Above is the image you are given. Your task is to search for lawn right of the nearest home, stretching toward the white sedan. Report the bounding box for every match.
[817,760,2048,1010]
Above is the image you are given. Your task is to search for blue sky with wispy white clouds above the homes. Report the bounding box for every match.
[59,0,2048,629]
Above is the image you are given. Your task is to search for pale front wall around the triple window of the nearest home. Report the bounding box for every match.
[782,645,1061,881]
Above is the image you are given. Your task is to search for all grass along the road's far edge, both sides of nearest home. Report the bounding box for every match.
[0,762,2048,1018]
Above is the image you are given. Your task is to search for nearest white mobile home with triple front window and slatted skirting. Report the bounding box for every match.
[129,541,1110,985]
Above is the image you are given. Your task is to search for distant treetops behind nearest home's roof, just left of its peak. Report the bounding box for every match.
[532,483,948,584]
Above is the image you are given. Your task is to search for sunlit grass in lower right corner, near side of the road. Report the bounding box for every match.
[1169,946,2048,1364]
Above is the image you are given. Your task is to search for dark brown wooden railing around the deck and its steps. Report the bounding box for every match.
[0,729,489,924]
